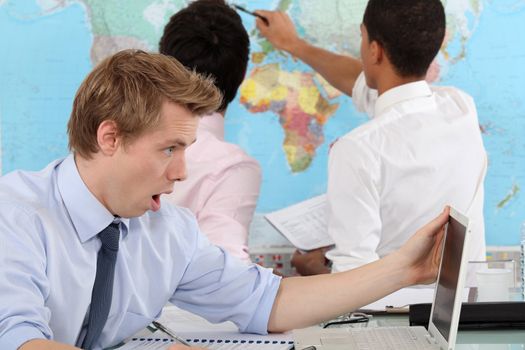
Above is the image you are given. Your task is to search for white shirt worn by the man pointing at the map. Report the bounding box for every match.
[327,74,486,272]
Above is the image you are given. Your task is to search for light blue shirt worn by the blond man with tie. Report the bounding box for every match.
[0,155,280,350]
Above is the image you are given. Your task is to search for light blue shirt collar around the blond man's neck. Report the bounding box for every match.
[57,154,129,243]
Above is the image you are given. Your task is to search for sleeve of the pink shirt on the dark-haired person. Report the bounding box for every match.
[197,161,261,263]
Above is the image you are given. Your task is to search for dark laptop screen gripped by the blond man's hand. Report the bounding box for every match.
[432,217,467,340]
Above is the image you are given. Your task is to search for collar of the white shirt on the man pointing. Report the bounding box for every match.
[374,80,432,117]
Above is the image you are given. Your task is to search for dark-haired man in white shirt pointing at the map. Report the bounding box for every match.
[257,0,487,278]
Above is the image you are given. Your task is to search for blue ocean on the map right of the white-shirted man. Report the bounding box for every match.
[444,2,525,245]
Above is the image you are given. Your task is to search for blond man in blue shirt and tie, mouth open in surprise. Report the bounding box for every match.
[0,50,447,350]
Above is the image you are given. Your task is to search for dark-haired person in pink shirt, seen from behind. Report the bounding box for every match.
[159,0,261,263]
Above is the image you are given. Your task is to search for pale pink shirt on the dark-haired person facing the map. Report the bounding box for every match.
[165,113,261,263]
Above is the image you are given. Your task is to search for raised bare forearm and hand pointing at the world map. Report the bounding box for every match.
[256,10,362,96]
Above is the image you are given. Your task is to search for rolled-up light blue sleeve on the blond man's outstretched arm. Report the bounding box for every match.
[170,219,281,334]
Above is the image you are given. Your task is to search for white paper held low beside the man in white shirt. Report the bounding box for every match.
[265,194,334,250]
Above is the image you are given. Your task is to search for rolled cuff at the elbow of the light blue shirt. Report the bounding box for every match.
[242,265,281,335]
